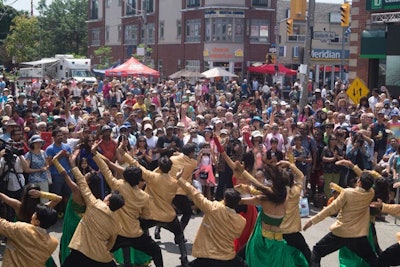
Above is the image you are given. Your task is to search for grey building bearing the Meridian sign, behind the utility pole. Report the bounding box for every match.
[277,1,350,86]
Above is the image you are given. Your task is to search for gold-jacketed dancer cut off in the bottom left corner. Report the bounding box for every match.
[0,204,58,267]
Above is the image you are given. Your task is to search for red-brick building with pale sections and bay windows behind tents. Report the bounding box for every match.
[87,0,277,78]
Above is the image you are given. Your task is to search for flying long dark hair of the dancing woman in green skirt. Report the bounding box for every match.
[255,164,290,204]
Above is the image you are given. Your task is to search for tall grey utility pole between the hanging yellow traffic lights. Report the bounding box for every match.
[300,0,315,112]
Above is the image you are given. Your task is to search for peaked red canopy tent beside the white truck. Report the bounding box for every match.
[105,57,160,77]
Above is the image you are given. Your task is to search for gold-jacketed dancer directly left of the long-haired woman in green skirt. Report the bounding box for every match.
[176,169,246,267]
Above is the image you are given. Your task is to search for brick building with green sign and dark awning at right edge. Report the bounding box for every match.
[349,0,400,97]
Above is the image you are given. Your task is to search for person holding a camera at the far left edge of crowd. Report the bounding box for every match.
[0,129,26,221]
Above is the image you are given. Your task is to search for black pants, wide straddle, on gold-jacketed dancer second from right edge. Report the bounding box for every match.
[311,233,378,267]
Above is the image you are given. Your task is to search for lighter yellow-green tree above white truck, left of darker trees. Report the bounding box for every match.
[5,15,40,62]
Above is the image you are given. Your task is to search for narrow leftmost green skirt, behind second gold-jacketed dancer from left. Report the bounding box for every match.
[60,197,86,265]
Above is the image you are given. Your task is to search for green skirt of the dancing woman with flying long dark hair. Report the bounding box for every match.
[246,214,296,267]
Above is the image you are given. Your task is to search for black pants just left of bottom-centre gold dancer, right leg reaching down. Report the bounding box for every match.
[140,217,188,266]
